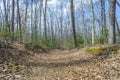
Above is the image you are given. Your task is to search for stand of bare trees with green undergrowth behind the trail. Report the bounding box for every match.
[0,0,120,49]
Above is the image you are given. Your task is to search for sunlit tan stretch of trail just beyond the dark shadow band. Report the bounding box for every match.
[33,49,92,63]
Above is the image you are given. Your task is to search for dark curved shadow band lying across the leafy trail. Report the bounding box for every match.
[27,53,110,68]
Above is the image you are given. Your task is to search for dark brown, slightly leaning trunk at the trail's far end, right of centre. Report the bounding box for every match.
[70,0,77,48]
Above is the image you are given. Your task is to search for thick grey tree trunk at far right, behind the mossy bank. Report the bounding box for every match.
[109,0,116,44]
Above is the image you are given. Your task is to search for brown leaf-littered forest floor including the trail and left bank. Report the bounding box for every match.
[0,42,120,80]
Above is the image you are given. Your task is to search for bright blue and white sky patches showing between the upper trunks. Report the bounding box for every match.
[0,0,120,36]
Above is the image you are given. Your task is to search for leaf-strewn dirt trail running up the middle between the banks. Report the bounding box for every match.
[25,49,92,80]
